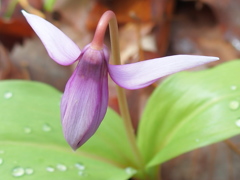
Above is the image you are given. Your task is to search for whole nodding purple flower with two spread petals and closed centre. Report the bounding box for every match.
[22,11,218,150]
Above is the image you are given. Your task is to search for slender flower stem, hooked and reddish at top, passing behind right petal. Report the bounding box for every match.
[91,11,144,169]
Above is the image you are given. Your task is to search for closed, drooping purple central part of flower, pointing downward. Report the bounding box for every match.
[61,48,108,150]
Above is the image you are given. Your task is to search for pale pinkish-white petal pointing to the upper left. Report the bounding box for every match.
[22,11,81,65]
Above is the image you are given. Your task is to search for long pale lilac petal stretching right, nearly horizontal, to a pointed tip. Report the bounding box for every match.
[108,55,218,89]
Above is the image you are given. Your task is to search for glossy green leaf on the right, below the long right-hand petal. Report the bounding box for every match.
[138,61,240,167]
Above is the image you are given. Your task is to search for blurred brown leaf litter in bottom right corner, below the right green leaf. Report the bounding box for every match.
[161,136,240,180]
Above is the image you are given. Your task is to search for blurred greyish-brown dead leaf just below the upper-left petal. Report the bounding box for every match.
[10,37,72,90]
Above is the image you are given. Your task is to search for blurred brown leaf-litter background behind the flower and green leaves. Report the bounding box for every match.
[0,0,240,180]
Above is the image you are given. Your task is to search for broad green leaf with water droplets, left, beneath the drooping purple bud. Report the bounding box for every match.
[0,81,135,180]
